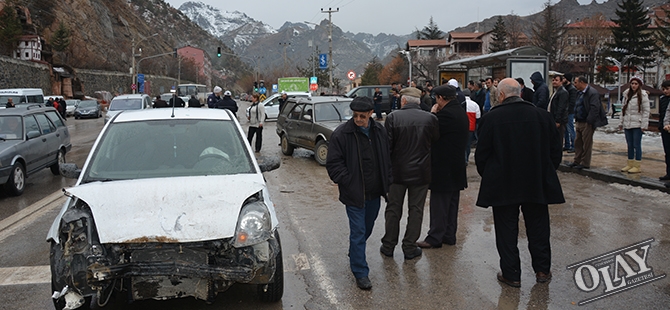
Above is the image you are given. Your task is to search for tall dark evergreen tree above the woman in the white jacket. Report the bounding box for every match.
[607,0,654,76]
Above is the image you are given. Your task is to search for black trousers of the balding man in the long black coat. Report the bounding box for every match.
[493,203,551,281]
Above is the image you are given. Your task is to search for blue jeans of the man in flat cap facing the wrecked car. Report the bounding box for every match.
[347,197,381,279]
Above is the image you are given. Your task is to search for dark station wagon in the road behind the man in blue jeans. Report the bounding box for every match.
[277,96,353,166]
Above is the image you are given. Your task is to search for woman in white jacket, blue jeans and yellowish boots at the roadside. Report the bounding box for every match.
[619,76,650,173]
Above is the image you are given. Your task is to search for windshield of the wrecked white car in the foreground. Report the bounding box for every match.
[83,119,255,182]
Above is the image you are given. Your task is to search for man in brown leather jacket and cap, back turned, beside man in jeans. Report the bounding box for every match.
[380,87,440,259]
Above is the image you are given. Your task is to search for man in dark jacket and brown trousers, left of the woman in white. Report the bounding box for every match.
[570,76,607,169]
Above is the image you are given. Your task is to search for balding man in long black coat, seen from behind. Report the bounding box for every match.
[475,78,565,287]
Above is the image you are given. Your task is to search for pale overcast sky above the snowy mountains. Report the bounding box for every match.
[165,0,605,35]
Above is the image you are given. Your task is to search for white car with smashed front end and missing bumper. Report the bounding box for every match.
[47,109,284,309]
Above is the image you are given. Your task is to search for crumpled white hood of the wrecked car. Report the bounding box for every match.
[67,174,265,243]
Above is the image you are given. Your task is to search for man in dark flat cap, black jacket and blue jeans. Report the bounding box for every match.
[326,97,392,290]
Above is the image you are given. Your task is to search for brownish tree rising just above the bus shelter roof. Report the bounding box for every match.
[531,1,565,68]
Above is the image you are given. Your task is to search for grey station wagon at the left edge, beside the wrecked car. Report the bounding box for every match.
[0,105,72,196]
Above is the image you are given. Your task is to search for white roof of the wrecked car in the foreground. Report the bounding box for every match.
[112,108,232,123]
